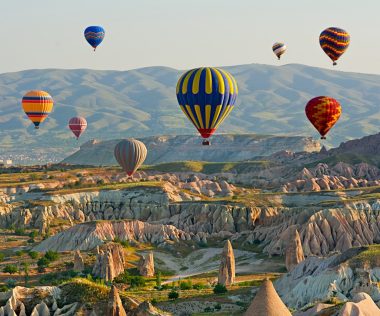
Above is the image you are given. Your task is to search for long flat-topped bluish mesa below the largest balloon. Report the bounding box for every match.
[63,134,320,166]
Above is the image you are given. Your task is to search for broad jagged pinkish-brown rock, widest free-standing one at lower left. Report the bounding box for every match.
[92,243,126,281]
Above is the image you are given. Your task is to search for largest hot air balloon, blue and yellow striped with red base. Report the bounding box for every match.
[177,67,238,145]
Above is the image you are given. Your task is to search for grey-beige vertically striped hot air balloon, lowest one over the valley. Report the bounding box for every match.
[114,138,147,176]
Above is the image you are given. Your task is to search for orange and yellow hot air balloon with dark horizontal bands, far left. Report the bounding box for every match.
[22,90,53,128]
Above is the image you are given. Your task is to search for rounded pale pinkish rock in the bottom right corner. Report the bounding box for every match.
[339,292,380,316]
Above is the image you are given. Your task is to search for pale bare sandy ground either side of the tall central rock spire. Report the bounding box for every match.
[140,248,263,283]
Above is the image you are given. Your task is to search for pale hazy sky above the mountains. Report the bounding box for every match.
[0,0,380,74]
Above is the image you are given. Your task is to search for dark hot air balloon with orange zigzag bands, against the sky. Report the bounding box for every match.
[319,27,350,66]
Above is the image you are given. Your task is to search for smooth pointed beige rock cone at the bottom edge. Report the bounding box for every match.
[244,280,292,316]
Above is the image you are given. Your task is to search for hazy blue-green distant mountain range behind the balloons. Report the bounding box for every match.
[0,64,380,160]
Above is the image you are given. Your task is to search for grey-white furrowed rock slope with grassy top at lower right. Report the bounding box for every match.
[275,247,380,309]
